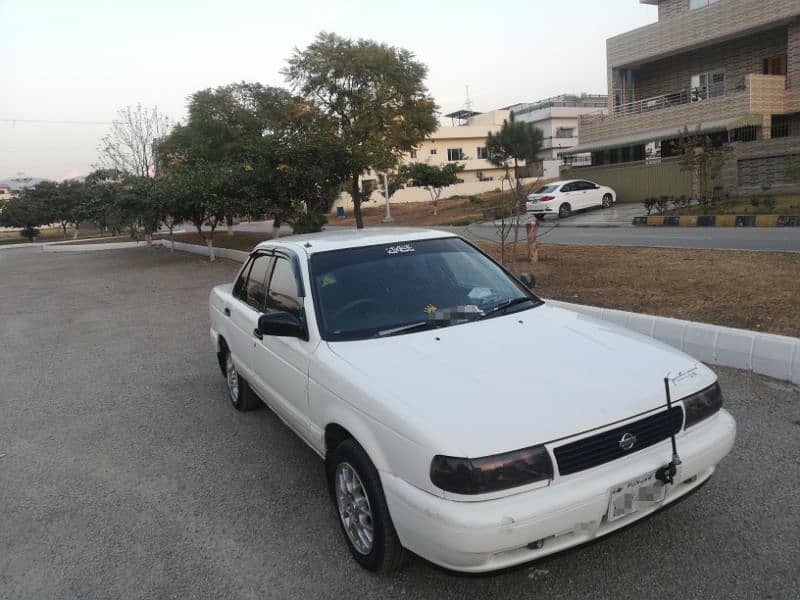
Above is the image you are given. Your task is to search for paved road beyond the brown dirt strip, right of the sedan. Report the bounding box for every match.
[454,222,800,252]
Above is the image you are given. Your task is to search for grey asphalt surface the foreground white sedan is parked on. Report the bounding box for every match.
[0,248,800,600]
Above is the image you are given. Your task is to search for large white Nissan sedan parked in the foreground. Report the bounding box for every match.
[209,228,736,572]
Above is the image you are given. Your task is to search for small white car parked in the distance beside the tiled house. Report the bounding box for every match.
[525,179,617,220]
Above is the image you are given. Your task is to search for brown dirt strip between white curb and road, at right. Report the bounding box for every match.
[479,242,800,336]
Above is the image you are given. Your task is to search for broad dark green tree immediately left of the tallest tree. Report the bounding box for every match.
[158,82,350,245]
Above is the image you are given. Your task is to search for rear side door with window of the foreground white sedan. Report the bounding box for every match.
[229,252,273,386]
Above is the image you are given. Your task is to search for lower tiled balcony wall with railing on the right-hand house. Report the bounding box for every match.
[574,74,787,152]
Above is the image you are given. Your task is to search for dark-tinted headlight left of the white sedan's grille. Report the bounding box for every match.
[431,446,553,494]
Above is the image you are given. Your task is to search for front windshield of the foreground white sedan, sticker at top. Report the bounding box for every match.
[310,238,541,340]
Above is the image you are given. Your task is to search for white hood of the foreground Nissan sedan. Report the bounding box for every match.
[329,304,716,457]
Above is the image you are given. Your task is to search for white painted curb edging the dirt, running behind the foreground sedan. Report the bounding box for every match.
[156,239,800,384]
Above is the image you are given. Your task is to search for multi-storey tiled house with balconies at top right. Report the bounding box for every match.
[567,0,800,193]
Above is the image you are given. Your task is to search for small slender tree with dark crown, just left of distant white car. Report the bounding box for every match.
[486,114,543,262]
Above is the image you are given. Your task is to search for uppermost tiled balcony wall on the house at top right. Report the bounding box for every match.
[607,0,800,68]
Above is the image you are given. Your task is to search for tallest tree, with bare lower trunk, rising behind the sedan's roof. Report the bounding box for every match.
[283,32,437,229]
